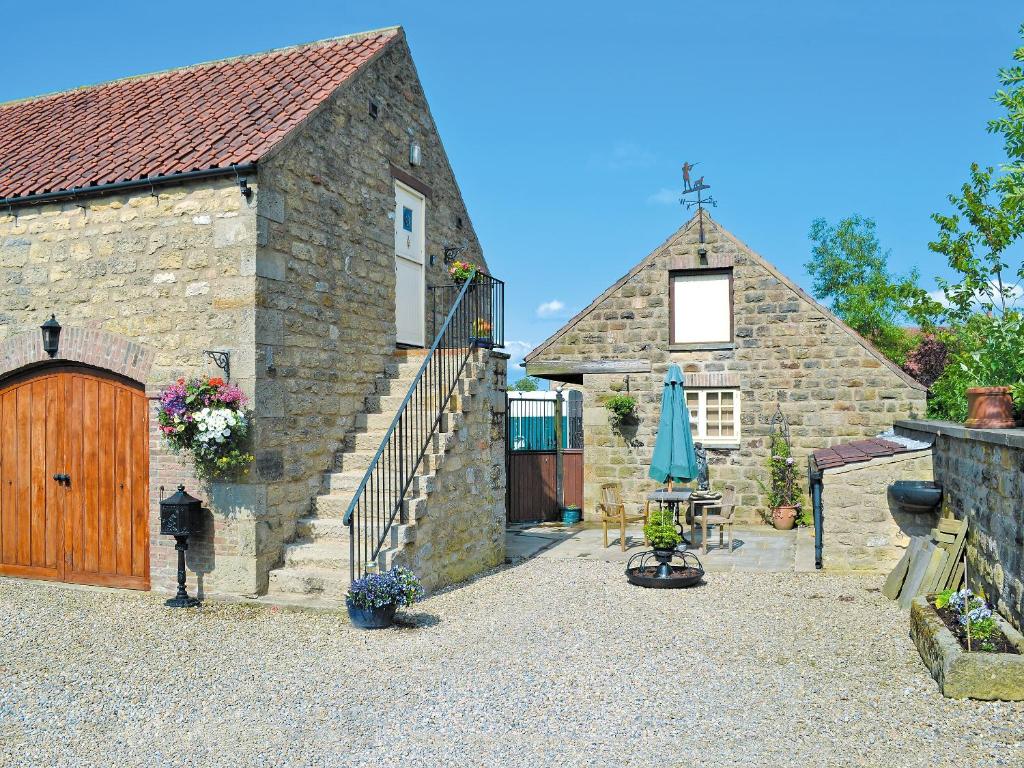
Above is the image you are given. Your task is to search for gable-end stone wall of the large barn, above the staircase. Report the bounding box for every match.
[247,39,484,590]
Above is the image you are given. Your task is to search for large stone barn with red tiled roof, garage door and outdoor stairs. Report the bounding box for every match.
[0,28,505,601]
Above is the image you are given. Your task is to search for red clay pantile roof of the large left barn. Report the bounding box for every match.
[0,28,400,199]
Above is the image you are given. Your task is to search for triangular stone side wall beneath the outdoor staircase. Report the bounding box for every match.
[398,352,508,590]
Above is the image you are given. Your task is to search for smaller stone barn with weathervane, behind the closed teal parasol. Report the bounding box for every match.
[525,212,926,520]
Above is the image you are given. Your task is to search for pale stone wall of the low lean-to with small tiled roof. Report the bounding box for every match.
[821,450,938,573]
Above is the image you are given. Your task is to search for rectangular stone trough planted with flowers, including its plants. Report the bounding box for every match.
[910,589,1024,701]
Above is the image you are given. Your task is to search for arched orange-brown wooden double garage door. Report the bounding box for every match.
[0,368,150,589]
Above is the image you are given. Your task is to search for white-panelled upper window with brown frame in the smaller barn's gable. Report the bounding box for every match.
[670,269,732,344]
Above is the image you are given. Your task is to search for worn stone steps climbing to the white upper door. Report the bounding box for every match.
[265,349,486,607]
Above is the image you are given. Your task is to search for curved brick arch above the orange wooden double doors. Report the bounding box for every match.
[0,327,156,384]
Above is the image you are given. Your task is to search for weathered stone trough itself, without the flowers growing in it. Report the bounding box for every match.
[910,596,1024,701]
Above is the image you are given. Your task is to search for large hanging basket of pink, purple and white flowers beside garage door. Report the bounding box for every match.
[157,377,253,479]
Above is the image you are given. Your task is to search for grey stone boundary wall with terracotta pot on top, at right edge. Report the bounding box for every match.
[896,421,1024,630]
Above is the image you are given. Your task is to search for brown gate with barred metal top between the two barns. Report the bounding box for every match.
[505,390,583,523]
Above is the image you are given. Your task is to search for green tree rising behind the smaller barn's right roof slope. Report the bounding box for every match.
[805,214,923,365]
